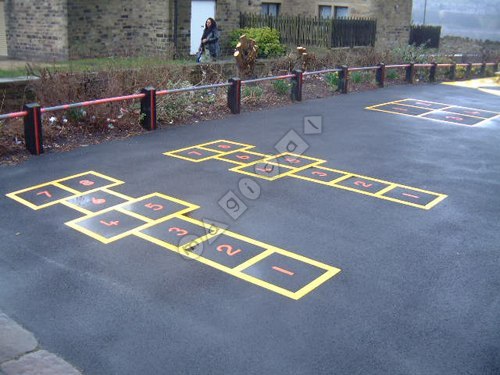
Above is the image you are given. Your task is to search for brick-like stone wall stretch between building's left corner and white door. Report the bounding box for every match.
[67,0,172,59]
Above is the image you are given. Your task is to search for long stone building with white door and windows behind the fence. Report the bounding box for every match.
[0,0,412,61]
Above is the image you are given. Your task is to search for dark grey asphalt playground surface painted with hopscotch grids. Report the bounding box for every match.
[0,81,500,375]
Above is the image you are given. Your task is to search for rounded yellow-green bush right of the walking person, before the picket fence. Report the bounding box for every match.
[230,27,286,57]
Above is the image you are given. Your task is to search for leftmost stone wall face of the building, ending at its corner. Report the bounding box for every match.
[5,0,68,61]
